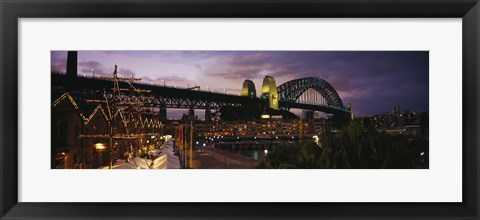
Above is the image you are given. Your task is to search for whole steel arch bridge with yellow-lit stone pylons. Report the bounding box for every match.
[52,51,351,121]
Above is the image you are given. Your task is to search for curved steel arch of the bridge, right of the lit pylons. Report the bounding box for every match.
[277,77,347,111]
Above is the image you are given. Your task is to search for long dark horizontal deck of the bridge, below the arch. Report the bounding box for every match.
[51,74,348,114]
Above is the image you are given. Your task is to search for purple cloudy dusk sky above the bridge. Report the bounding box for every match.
[51,51,429,116]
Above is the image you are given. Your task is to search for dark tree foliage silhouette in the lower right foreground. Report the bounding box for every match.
[259,120,429,169]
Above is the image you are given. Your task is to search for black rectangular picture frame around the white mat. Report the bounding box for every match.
[0,0,480,219]
